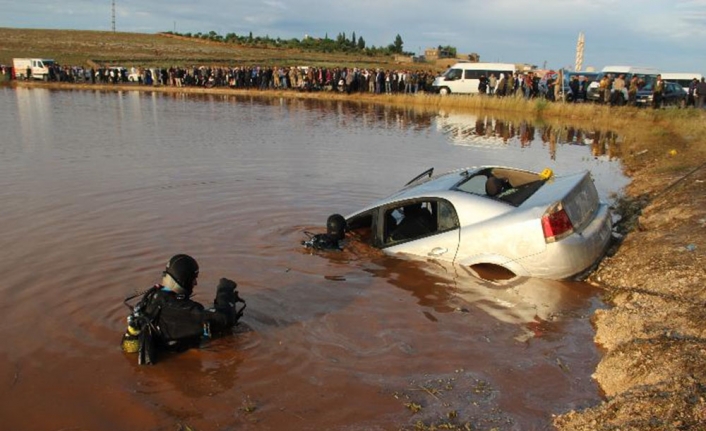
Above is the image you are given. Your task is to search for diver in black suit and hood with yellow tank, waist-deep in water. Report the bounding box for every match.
[122,254,245,364]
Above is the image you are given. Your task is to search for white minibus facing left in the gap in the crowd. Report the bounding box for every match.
[431,63,515,94]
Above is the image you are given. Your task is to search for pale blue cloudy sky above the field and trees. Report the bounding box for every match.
[0,0,706,75]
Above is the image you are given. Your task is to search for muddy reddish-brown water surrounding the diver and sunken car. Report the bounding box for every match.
[0,88,626,431]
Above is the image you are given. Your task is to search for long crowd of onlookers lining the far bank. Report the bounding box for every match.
[0,64,706,108]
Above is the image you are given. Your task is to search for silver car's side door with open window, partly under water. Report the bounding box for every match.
[376,198,460,262]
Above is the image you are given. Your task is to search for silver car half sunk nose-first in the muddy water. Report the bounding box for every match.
[346,166,612,280]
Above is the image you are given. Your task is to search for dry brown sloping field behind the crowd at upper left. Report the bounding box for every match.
[0,28,435,68]
